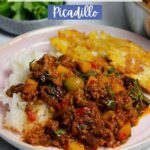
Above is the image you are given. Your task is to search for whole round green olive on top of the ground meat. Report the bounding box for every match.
[64,76,84,91]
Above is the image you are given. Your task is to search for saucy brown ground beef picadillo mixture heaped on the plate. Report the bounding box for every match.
[6,54,149,150]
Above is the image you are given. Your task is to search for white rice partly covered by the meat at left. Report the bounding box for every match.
[0,51,55,133]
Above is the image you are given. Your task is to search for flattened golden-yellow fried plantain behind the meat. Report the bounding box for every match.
[51,29,150,92]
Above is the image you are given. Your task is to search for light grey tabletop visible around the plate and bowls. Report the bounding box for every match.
[0,2,150,150]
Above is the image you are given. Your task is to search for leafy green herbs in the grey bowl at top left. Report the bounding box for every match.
[0,0,64,21]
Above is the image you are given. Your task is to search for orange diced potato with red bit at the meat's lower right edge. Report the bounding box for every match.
[118,122,131,141]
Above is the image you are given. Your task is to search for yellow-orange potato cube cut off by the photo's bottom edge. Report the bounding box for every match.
[67,141,85,150]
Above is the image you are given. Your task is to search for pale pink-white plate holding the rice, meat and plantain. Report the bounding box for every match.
[0,24,150,150]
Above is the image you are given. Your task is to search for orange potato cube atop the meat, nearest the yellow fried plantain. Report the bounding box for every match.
[78,61,92,73]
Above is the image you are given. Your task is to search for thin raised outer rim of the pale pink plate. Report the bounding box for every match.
[0,23,150,150]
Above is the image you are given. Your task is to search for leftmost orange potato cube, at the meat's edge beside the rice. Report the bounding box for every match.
[23,79,38,93]
